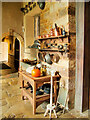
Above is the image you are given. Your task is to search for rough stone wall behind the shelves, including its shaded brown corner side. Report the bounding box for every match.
[40,2,76,108]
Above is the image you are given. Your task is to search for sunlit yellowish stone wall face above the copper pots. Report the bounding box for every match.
[40,2,68,35]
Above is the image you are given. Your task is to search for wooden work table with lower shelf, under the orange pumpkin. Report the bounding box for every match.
[19,71,59,114]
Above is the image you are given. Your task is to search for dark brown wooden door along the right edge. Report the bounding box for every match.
[82,2,90,111]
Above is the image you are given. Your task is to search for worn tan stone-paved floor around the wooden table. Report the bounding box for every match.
[0,62,89,119]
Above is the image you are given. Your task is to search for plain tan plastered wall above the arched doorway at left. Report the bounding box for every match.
[2,2,23,36]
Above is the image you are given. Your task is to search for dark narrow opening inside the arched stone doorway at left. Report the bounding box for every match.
[14,38,20,71]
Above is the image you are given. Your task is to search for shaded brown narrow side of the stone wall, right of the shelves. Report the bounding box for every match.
[68,2,76,108]
